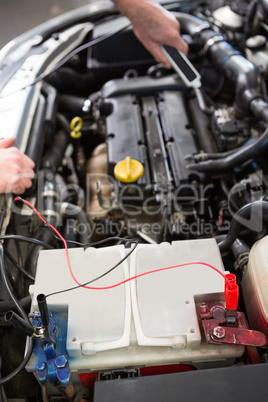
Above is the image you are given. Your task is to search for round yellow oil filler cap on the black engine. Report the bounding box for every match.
[114,156,144,183]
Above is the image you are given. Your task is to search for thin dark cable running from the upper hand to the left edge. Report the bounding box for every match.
[0,23,130,98]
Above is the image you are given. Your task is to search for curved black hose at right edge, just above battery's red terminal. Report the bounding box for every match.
[218,201,268,251]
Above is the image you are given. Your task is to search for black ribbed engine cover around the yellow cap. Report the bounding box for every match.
[102,76,201,193]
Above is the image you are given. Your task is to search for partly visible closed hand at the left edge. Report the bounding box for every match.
[0,138,34,194]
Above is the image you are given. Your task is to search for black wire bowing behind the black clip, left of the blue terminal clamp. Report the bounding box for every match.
[0,242,33,386]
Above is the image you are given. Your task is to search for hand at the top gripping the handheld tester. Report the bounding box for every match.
[113,0,188,68]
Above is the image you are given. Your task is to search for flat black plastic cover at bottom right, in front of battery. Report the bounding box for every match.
[94,364,268,402]
